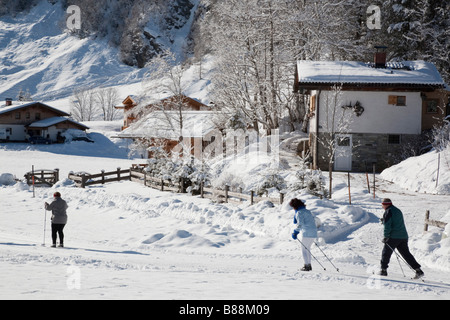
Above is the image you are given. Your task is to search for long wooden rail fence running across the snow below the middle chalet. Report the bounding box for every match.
[69,165,284,205]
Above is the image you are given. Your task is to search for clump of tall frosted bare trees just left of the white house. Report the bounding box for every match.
[209,0,295,132]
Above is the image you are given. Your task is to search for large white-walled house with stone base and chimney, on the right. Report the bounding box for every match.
[295,52,450,172]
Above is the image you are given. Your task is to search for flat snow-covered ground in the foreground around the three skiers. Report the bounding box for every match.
[0,123,450,300]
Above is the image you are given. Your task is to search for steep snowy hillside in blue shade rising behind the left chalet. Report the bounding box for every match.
[0,1,209,107]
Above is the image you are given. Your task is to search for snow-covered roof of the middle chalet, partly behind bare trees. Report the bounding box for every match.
[118,111,215,140]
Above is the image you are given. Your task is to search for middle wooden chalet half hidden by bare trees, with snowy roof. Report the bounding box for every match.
[116,95,214,158]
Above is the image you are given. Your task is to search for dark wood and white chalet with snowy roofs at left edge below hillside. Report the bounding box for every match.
[0,99,89,142]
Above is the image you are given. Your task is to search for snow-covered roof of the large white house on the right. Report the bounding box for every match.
[297,60,445,87]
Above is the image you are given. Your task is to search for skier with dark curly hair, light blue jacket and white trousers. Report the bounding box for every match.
[289,198,317,271]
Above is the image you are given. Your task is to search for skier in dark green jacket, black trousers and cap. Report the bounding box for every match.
[379,198,424,279]
